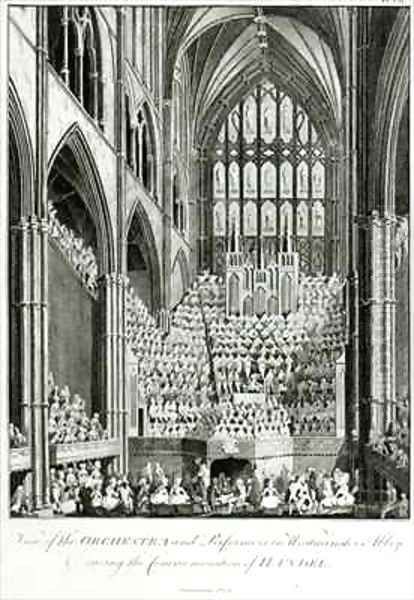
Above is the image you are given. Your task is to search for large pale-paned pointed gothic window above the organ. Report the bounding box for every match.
[212,83,326,273]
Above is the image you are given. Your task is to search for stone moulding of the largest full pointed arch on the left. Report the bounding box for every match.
[48,123,115,273]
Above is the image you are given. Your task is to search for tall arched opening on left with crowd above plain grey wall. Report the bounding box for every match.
[48,145,100,412]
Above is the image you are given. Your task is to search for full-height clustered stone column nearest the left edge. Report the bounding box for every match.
[29,7,50,509]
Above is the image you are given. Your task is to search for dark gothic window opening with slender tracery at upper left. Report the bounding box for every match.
[48,6,103,127]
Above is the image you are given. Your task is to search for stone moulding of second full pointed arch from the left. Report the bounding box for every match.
[124,198,161,312]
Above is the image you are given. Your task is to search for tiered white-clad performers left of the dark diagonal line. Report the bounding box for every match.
[127,282,213,437]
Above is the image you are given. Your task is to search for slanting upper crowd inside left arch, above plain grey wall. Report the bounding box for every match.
[48,201,98,293]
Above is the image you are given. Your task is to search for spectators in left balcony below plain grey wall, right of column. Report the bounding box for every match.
[49,374,109,444]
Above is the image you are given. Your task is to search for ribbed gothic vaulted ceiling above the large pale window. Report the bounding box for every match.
[167,6,347,149]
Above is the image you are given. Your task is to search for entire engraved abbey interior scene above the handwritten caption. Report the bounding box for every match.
[7,5,410,518]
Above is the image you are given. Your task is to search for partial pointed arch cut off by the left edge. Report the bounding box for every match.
[8,79,34,222]
